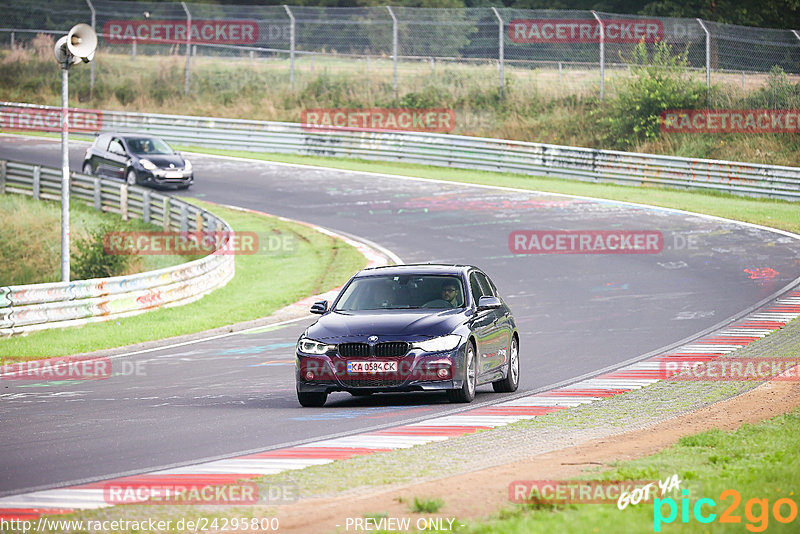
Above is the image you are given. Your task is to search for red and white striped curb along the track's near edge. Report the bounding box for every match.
[0,291,800,519]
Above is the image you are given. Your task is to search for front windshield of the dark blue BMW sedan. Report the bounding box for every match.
[335,274,464,311]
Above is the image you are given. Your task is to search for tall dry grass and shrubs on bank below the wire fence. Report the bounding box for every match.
[6,44,800,165]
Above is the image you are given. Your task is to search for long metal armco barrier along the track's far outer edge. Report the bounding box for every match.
[0,102,800,200]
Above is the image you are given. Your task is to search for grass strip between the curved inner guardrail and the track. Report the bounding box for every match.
[0,200,366,362]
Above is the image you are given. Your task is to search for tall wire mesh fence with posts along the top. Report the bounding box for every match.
[0,0,800,97]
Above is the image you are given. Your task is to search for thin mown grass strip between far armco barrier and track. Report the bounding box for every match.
[180,146,800,233]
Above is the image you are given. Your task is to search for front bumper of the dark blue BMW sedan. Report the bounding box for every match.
[295,345,464,393]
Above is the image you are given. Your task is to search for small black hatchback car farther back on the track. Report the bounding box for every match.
[82,133,194,189]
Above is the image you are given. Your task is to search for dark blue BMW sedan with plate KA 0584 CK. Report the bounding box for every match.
[295,264,519,406]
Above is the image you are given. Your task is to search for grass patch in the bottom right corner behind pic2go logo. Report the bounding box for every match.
[464,411,800,534]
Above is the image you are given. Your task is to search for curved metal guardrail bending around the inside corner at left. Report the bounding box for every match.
[0,161,235,335]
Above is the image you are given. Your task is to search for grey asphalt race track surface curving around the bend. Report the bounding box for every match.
[0,136,800,495]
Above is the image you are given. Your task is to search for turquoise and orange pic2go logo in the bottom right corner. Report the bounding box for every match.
[653,489,797,532]
